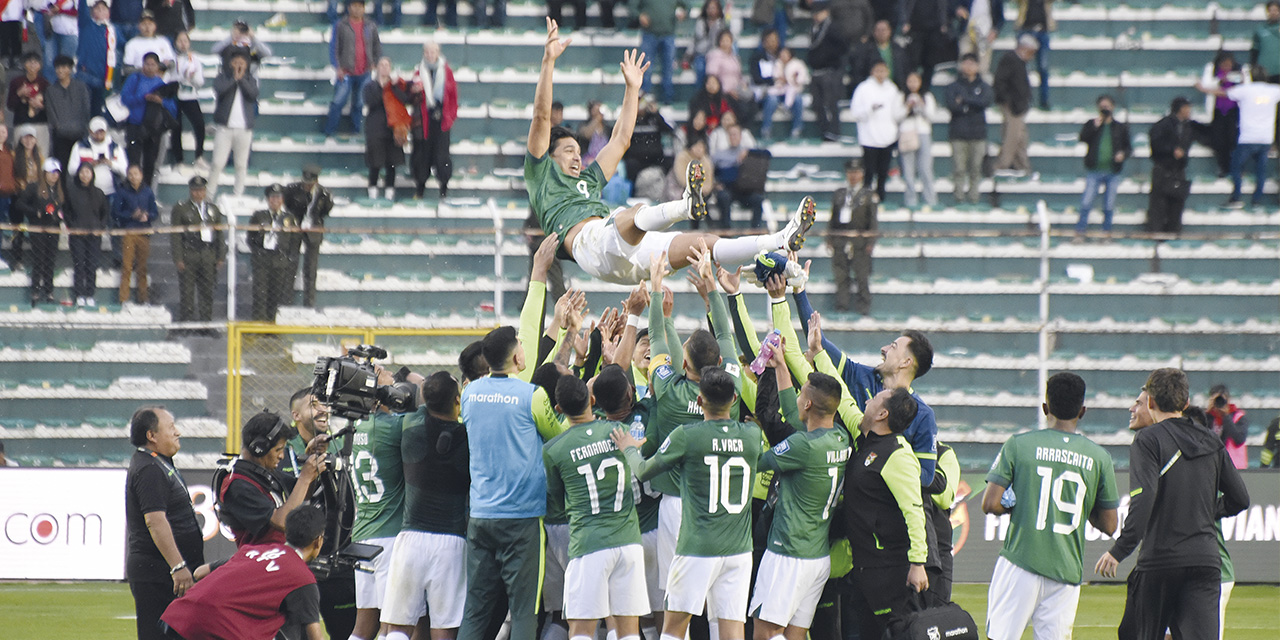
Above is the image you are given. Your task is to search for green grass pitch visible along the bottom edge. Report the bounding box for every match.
[0,582,1280,640]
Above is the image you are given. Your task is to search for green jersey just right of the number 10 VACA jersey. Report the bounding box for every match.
[760,426,852,558]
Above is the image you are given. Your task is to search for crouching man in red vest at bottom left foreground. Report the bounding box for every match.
[161,506,325,640]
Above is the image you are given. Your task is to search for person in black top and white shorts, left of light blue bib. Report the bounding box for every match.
[383,371,471,640]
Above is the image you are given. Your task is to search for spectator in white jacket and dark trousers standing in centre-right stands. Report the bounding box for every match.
[851,60,906,202]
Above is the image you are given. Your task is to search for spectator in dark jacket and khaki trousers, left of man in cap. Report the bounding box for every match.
[946,54,992,205]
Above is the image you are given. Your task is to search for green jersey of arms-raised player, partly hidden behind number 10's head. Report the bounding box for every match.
[649,353,742,498]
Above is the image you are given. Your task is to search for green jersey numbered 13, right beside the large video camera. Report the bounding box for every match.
[351,413,404,540]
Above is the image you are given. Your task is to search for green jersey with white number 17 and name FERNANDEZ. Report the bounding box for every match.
[543,420,640,558]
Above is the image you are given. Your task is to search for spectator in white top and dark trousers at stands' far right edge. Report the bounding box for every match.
[1197,65,1280,209]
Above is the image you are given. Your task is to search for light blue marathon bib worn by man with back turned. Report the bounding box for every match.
[462,376,554,518]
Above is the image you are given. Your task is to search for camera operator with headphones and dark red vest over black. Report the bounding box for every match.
[214,411,329,548]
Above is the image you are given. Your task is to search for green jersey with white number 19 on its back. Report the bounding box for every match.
[987,429,1120,585]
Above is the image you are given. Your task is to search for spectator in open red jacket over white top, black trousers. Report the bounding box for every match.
[410,41,458,200]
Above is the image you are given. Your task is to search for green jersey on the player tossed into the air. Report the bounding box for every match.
[525,151,609,251]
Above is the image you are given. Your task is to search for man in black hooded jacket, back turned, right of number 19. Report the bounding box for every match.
[1094,369,1249,640]
